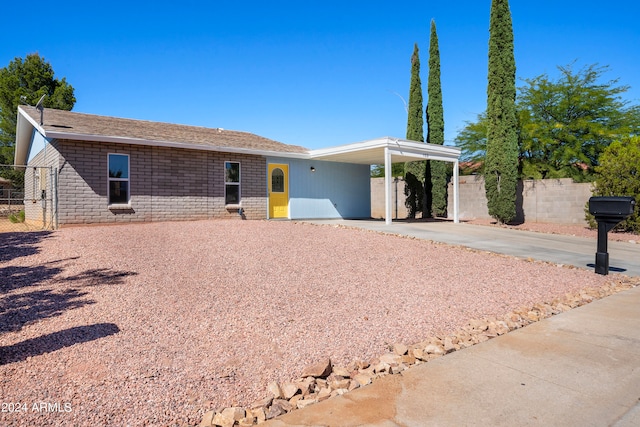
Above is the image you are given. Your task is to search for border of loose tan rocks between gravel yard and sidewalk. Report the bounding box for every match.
[200,277,640,427]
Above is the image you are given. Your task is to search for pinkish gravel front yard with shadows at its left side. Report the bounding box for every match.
[0,220,628,426]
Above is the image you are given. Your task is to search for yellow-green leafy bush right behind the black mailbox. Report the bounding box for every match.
[586,136,640,233]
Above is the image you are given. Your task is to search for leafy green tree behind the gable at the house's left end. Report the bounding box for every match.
[0,53,76,169]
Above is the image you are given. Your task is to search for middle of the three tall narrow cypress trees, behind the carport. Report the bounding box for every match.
[426,20,448,216]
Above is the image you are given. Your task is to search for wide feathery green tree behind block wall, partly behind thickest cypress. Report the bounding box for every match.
[456,64,640,181]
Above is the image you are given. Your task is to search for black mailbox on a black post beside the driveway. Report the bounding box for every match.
[589,197,636,275]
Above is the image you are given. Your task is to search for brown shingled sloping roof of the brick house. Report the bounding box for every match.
[20,105,308,153]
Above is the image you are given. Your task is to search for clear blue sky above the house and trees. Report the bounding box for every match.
[5,0,640,149]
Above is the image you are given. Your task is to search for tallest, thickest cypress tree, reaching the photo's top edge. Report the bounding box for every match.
[484,0,518,223]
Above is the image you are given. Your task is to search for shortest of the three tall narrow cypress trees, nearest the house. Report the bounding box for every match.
[404,43,425,218]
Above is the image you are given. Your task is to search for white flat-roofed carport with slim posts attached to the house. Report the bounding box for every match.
[309,137,460,224]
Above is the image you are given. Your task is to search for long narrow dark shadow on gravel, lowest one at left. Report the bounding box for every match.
[0,323,120,365]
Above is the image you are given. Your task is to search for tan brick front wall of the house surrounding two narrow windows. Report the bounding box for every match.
[34,140,267,225]
